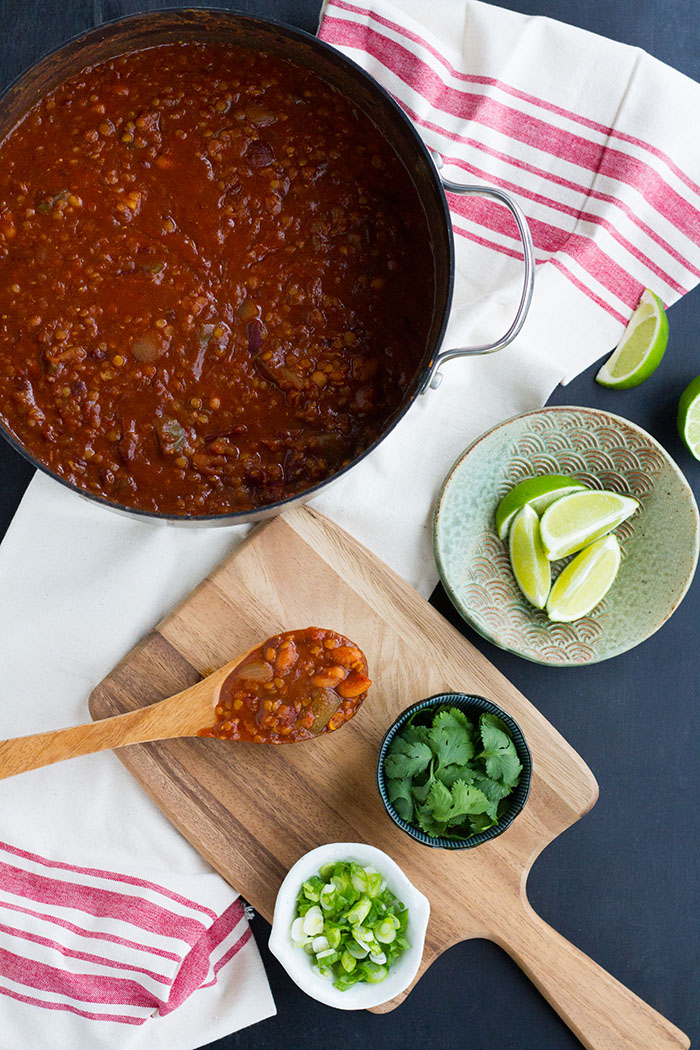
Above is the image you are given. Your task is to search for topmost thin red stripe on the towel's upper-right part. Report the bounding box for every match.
[319,0,700,195]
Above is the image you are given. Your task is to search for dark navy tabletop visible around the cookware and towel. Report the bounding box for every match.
[0,0,700,1050]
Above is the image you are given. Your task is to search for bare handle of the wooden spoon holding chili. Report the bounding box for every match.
[0,687,201,780]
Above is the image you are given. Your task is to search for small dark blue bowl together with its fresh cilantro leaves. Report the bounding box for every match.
[377,693,531,849]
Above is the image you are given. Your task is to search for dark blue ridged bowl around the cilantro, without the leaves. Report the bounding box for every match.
[377,693,532,849]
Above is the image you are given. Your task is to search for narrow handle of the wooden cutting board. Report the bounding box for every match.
[493,895,691,1050]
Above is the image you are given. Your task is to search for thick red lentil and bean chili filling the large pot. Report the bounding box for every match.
[0,43,433,517]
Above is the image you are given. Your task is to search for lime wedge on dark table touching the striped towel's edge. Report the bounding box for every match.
[595,289,669,390]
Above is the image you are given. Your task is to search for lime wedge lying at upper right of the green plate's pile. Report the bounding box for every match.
[539,489,639,562]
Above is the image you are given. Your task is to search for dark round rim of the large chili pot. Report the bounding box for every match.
[0,7,454,525]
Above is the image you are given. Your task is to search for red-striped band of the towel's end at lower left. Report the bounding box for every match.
[0,842,251,1025]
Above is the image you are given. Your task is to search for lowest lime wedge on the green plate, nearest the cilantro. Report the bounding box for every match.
[547,536,620,624]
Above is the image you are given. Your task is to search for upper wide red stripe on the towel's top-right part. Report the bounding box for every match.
[324,15,700,244]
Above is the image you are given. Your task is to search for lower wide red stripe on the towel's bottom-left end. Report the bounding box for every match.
[0,948,161,1011]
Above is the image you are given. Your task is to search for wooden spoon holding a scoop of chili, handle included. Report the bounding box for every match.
[0,627,372,779]
